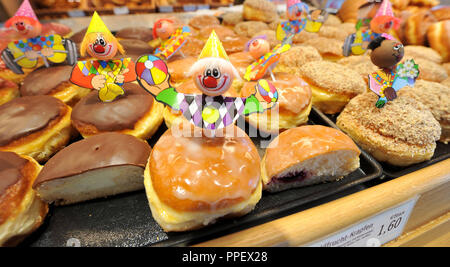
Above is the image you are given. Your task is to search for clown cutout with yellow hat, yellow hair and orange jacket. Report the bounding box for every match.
[70,12,136,102]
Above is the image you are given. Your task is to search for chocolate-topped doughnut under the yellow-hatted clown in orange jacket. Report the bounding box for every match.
[71,83,164,140]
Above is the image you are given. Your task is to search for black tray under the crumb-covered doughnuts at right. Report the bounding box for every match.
[321,113,450,178]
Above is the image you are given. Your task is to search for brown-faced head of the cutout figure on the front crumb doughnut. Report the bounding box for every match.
[369,37,405,69]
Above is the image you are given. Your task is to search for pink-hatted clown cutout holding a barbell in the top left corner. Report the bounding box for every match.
[1,0,77,74]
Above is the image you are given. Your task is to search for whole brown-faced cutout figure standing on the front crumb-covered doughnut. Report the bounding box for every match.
[368,34,419,108]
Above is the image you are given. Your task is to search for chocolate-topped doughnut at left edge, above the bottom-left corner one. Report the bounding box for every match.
[0,95,73,162]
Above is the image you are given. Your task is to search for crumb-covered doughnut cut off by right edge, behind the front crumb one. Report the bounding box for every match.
[399,80,450,143]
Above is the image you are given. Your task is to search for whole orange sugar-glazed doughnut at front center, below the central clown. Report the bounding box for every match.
[144,124,262,232]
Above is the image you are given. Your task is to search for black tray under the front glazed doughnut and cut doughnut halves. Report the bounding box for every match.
[22,109,382,247]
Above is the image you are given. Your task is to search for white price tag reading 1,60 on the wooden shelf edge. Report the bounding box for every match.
[307,197,418,247]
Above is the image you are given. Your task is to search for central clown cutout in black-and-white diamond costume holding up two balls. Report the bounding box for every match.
[136,31,278,131]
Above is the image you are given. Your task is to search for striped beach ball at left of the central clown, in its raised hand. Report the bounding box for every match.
[136,55,167,85]
